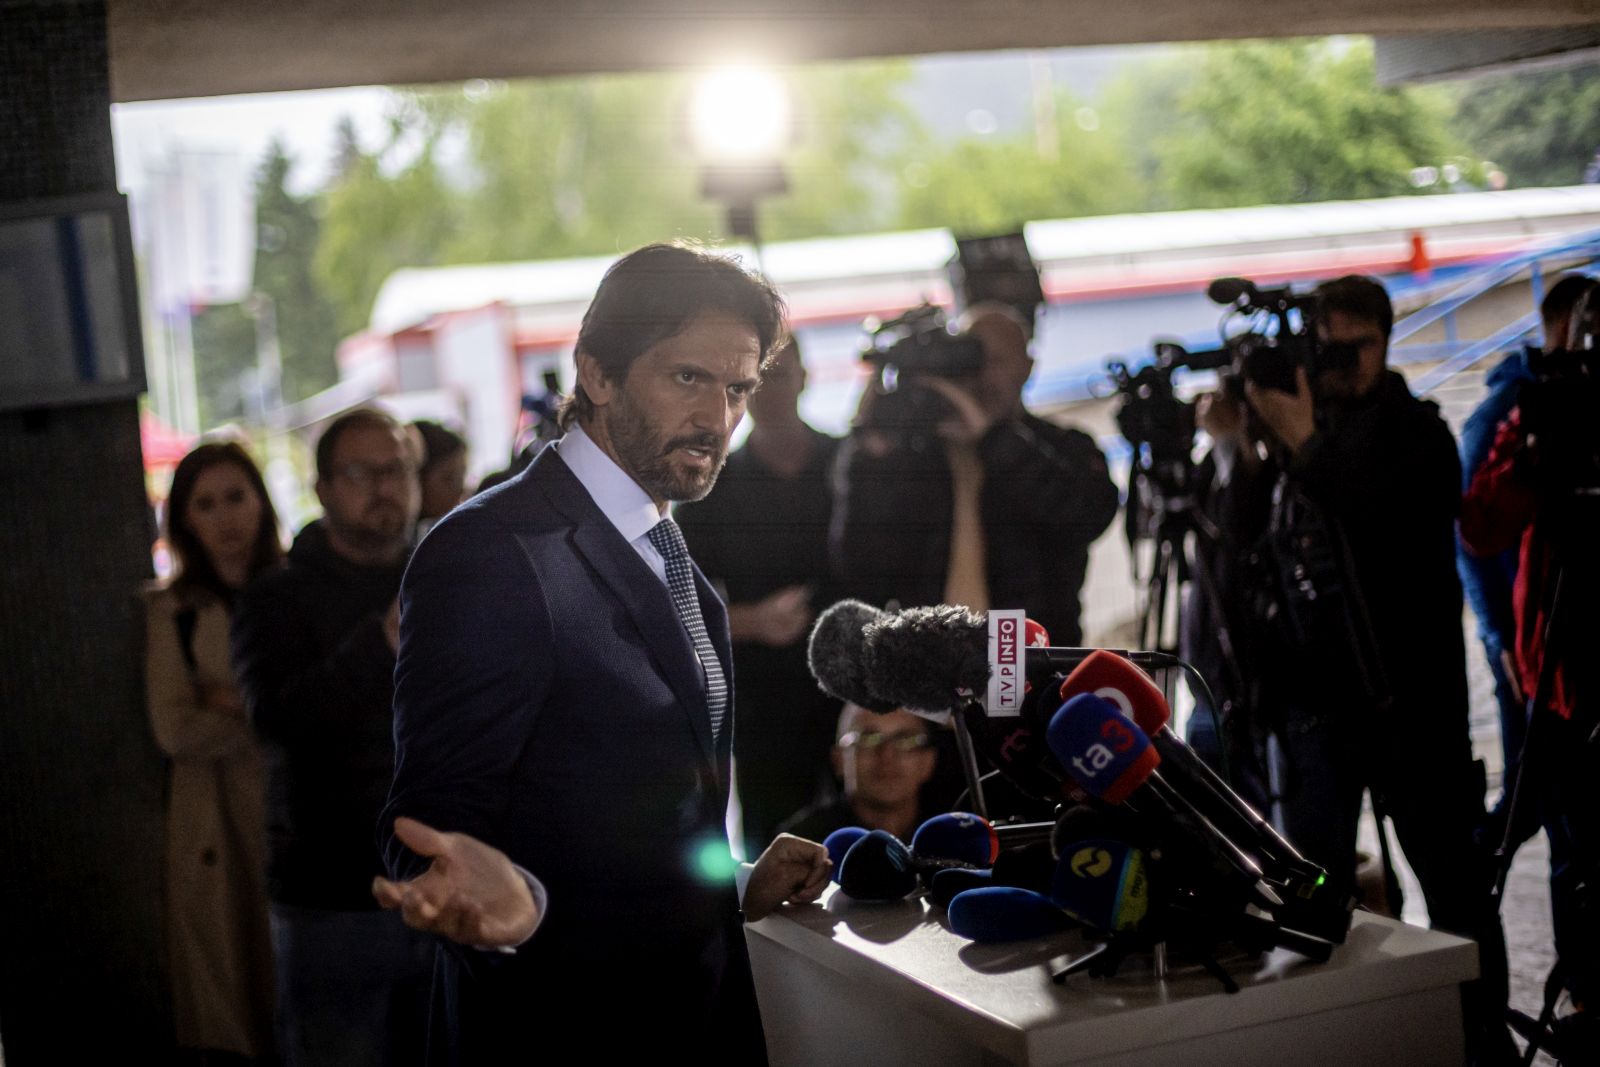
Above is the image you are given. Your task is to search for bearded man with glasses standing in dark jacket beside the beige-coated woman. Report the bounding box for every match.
[234,408,434,1067]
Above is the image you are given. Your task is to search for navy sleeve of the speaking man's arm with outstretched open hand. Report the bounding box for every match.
[378,510,554,878]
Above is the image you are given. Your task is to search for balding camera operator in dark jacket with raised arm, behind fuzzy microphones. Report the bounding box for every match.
[830,304,1118,645]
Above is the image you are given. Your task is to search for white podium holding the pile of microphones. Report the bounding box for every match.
[746,886,1477,1067]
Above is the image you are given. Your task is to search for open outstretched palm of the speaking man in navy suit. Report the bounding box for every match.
[373,816,539,949]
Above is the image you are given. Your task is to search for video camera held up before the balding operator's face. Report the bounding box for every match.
[859,304,984,446]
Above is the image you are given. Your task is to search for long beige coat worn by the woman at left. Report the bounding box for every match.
[146,587,272,1056]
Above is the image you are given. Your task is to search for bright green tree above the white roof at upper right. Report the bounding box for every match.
[1107,40,1454,208]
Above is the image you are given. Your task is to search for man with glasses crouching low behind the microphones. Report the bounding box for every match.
[782,704,939,841]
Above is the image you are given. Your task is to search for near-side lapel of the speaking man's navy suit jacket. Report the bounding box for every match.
[528,448,726,768]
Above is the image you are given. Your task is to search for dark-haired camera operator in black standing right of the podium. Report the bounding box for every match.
[1245,275,1510,1059]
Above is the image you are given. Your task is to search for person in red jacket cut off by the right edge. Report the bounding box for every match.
[1461,282,1600,1062]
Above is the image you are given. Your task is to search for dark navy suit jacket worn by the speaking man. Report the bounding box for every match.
[379,448,763,1062]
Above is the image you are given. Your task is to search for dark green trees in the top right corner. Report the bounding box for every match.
[1456,64,1600,186]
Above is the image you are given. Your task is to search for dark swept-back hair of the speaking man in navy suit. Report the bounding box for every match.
[557,243,786,430]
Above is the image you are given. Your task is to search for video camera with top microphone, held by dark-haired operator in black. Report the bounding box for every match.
[1206,278,1357,392]
